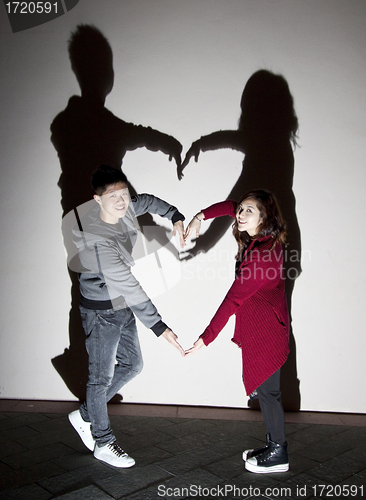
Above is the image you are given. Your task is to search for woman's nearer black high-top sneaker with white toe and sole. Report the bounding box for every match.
[245,440,289,474]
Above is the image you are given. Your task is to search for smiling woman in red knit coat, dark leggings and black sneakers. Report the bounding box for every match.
[185,190,289,473]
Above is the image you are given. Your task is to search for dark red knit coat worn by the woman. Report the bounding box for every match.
[201,200,289,395]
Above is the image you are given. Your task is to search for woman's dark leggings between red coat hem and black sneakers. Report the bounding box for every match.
[257,370,286,444]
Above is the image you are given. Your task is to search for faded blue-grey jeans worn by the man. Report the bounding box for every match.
[80,307,143,446]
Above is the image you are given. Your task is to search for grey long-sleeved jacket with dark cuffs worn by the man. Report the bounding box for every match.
[73,194,184,335]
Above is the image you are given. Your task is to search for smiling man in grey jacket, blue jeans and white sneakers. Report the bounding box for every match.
[69,165,184,467]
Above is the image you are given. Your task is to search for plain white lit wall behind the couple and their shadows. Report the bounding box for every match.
[0,0,366,412]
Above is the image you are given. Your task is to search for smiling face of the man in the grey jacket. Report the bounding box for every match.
[94,182,130,224]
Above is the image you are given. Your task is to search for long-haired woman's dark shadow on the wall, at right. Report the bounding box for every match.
[182,70,301,411]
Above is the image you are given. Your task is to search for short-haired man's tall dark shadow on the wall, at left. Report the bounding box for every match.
[51,25,182,401]
